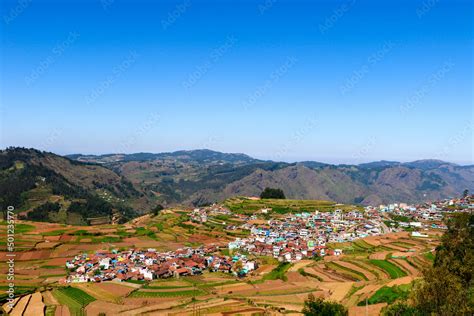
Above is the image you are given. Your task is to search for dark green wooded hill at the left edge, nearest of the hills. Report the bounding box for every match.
[0,148,141,224]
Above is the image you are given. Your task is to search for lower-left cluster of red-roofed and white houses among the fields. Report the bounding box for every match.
[65,246,257,283]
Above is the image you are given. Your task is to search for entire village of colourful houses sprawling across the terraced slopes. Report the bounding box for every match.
[65,198,474,283]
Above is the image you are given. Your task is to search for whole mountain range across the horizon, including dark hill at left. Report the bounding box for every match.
[0,148,474,222]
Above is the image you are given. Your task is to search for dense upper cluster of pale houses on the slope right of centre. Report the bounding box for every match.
[224,210,383,262]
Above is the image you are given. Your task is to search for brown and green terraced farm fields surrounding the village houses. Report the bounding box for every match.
[0,215,438,316]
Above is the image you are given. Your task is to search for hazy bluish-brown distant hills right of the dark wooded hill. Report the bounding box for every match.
[71,150,474,205]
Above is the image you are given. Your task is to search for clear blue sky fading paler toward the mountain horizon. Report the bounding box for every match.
[0,0,473,164]
